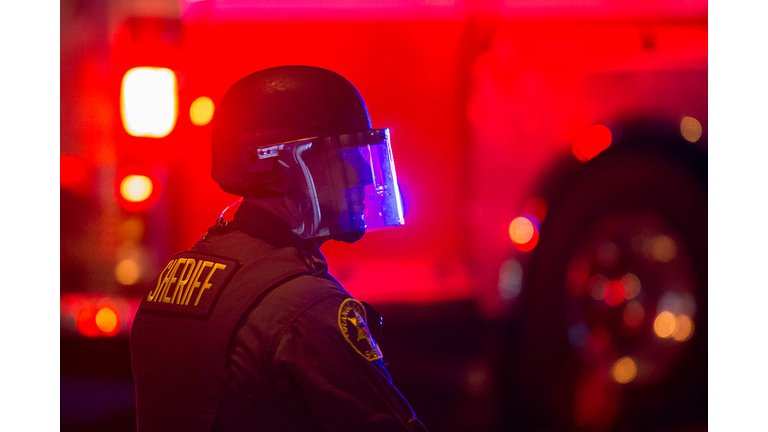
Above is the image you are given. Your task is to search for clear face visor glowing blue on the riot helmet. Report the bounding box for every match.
[257,129,405,238]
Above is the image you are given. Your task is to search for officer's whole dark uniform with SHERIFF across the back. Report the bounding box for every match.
[130,202,426,432]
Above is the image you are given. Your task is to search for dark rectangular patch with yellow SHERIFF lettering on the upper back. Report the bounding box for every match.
[140,251,240,317]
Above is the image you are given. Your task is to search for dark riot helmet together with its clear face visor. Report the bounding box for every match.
[211,66,404,238]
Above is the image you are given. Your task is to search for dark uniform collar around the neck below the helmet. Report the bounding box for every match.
[232,200,325,262]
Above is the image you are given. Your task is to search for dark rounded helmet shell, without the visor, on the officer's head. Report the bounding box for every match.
[211,66,371,198]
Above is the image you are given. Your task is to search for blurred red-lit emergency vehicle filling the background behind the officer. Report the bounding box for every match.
[61,0,707,430]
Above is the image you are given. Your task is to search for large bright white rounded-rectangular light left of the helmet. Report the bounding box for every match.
[120,67,178,138]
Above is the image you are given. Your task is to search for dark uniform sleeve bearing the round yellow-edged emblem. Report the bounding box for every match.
[274,295,426,431]
